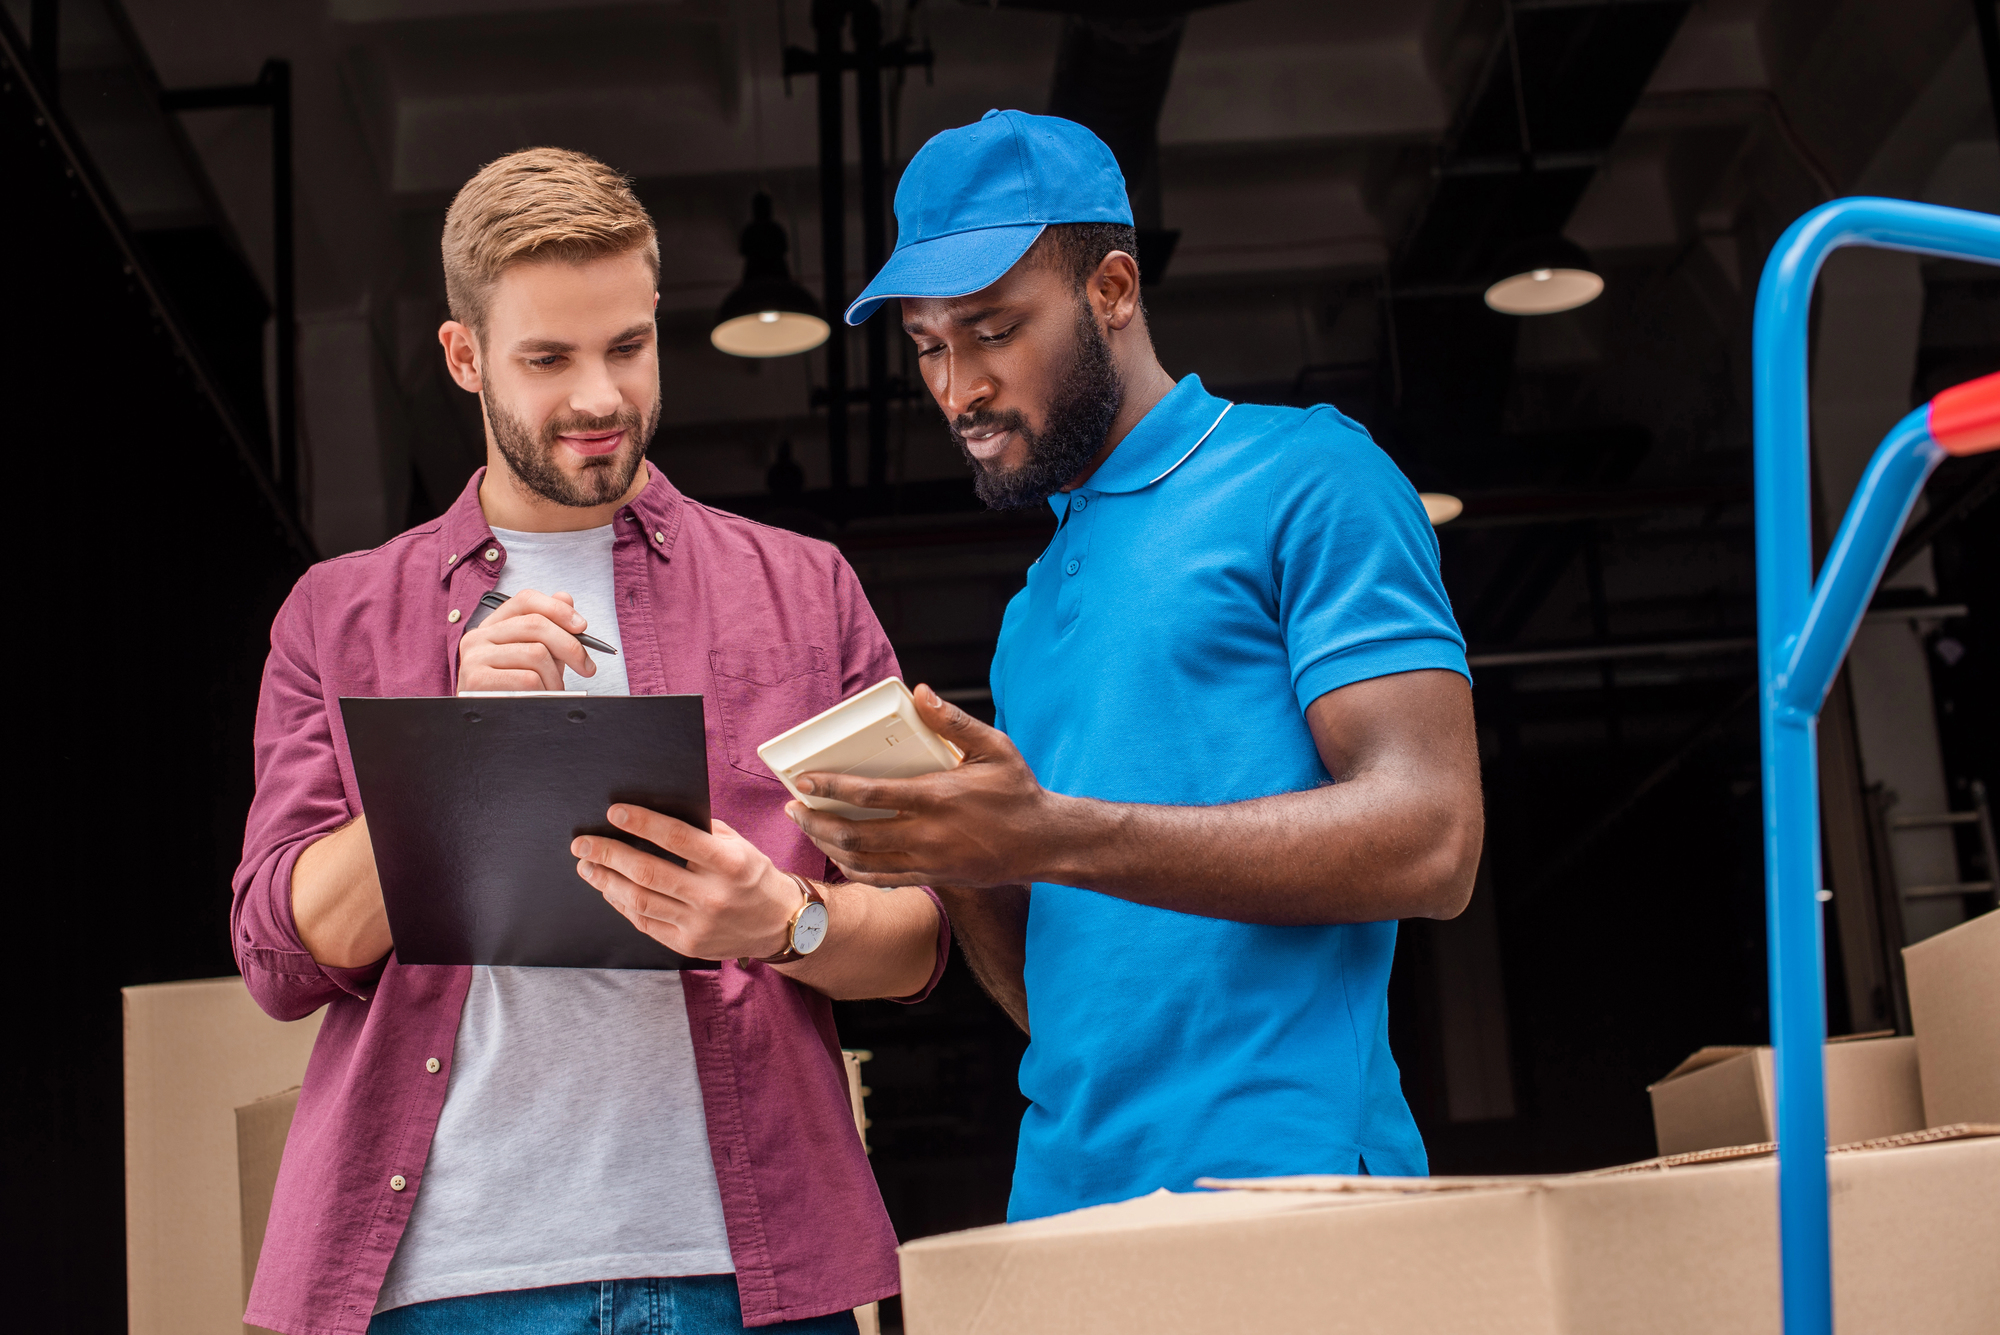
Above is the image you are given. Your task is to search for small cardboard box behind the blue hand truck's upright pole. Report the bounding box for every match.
[1646,1037,1920,1155]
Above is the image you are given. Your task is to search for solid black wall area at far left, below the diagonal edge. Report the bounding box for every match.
[0,20,312,1331]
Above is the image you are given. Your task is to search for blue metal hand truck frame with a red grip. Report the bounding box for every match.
[1754,198,2000,1335]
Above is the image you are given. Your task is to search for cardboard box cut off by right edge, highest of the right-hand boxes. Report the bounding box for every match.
[1902,911,2000,1127]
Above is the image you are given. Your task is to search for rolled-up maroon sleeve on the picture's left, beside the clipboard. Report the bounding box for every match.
[230,572,380,1019]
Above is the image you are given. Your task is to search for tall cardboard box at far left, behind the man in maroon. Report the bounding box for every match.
[124,977,320,1335]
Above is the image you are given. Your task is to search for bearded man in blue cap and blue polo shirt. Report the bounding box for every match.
[790,112,1482,1219]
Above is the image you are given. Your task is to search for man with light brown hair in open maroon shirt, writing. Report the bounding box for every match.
[230,150,948,1335]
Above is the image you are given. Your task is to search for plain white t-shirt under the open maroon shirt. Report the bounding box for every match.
[376,526,736,1311]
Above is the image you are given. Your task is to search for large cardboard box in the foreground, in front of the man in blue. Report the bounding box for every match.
[900,1133,2000,1335]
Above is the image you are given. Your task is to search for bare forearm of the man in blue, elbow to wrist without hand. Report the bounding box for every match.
[1036,775,1484,925]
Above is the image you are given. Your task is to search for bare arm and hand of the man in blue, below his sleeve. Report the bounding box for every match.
[786,669,1486,925]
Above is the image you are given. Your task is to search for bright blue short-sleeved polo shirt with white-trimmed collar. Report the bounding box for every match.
[992,376,1470,1219]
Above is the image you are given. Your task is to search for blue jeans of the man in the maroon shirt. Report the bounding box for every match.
[368,1275,854,1335]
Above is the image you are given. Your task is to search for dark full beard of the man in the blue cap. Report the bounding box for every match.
[946,302,1124,510]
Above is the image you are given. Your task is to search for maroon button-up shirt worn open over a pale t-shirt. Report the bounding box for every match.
[230,468,950,1335]
